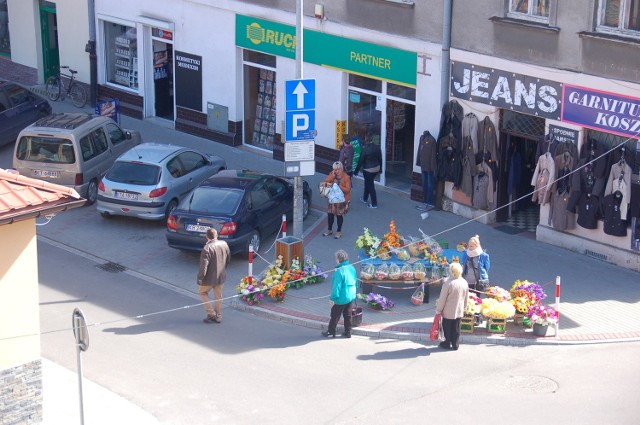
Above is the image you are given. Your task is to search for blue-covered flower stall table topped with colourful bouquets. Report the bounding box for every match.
[355,220,460,304]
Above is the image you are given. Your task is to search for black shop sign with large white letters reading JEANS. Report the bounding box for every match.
[451,62,562,120]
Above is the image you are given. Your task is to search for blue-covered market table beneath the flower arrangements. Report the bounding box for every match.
[358,249,460,303]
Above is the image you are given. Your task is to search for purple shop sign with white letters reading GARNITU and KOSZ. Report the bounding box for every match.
[562,84,640,139]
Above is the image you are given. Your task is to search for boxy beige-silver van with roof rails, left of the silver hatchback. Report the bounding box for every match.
[13,113,142,205]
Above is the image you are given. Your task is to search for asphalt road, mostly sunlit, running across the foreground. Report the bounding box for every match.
[38,238,640,425]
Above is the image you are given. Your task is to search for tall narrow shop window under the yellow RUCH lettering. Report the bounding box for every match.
[243,50,276,151]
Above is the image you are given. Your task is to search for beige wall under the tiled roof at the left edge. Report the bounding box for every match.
[0,220,40,370]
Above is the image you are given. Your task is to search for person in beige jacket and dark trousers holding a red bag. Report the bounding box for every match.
[436,263,469,350]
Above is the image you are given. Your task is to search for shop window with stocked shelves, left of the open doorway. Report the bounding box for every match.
[104,22,138,89]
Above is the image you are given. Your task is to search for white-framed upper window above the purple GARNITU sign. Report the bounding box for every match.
[597,0,640,37]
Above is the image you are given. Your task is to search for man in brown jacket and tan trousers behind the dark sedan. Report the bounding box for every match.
[198,227,231,323]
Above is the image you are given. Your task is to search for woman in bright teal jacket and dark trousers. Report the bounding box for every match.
[322,249,358,338]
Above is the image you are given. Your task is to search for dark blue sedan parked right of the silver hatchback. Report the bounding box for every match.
[166,170,311,254]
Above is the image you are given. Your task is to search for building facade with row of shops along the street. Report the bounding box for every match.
[0,0,640,269]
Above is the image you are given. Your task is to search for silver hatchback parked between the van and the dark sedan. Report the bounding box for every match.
[97,143,227,220]
